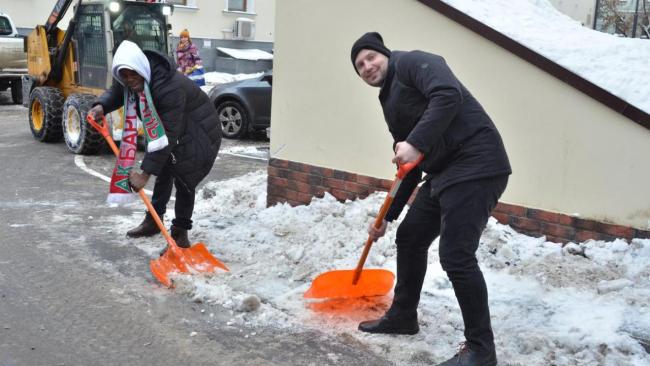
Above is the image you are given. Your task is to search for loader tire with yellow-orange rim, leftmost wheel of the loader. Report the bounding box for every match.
[29,86,65,142]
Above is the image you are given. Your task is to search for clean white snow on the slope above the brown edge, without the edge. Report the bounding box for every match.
[443,0,650,113]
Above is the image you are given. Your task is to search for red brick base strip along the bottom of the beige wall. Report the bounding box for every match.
[267,159,650,243]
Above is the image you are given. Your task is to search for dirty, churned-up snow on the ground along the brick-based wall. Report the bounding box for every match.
[115,171,650,366]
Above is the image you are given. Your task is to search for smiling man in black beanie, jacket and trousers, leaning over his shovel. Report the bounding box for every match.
[351,32,511,366]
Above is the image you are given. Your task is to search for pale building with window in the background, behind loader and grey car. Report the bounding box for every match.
[0,0,275,73]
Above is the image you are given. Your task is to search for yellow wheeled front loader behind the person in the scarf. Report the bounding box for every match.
[23,0,172,154]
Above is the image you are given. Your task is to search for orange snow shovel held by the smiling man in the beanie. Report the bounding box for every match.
[304,155,424,298]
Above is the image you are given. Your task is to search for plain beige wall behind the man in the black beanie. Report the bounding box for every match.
[271,0,650,230]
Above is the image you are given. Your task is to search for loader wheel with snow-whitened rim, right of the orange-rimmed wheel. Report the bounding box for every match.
[63,94,104,155]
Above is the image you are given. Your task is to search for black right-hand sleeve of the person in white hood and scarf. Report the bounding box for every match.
[140,82,186,175]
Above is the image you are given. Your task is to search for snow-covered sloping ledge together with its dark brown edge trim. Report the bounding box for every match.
[418,0,650,129]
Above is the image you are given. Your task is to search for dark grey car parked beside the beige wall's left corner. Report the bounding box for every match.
[208,71,273,139]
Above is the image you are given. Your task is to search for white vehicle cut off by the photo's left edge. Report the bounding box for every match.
[0,12,27,104]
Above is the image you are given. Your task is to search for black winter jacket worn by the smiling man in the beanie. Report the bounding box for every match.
[379,51,512,221]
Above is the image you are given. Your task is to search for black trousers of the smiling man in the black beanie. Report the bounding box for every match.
[389,175,508,350]
